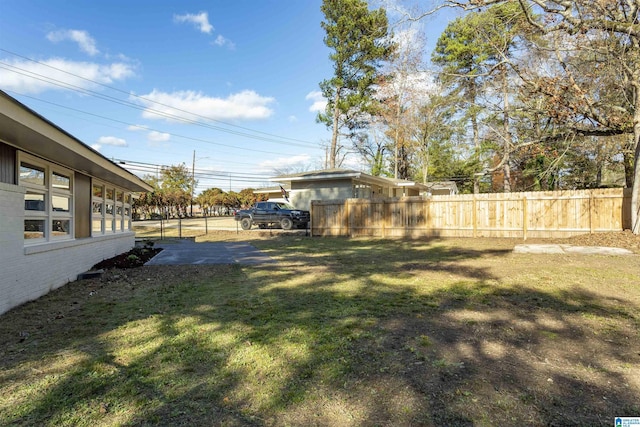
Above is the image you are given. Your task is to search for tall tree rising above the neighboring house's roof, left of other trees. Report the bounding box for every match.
[317,0,394,168]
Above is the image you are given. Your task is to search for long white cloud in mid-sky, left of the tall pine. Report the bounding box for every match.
[134,90,275,122]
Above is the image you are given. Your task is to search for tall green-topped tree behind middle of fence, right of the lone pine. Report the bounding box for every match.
[432,2,535,191]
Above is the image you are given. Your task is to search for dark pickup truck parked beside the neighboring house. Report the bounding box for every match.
[235,202,311,230]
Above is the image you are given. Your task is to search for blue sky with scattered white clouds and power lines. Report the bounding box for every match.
[0,0,456,193]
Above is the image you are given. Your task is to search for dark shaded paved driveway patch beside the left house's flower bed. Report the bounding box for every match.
[145,239,275,265]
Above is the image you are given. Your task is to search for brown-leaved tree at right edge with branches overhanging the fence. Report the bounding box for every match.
[436,0,640,234]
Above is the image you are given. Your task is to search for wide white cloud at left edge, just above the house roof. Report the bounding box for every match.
[0,58,135,94]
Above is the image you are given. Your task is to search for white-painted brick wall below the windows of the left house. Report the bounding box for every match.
[0,183,135,314]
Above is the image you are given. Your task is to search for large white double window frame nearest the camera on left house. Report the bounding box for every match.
[18,152,75,245]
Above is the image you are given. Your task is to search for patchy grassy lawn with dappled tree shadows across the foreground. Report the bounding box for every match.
[0,235,640,426]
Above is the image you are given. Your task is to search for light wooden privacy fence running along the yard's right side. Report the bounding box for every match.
[311,188,631,239]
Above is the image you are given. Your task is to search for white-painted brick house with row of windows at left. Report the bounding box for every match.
[0,91,151,314]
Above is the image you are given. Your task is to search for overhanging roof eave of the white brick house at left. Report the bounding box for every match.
[0,90,153,191]
